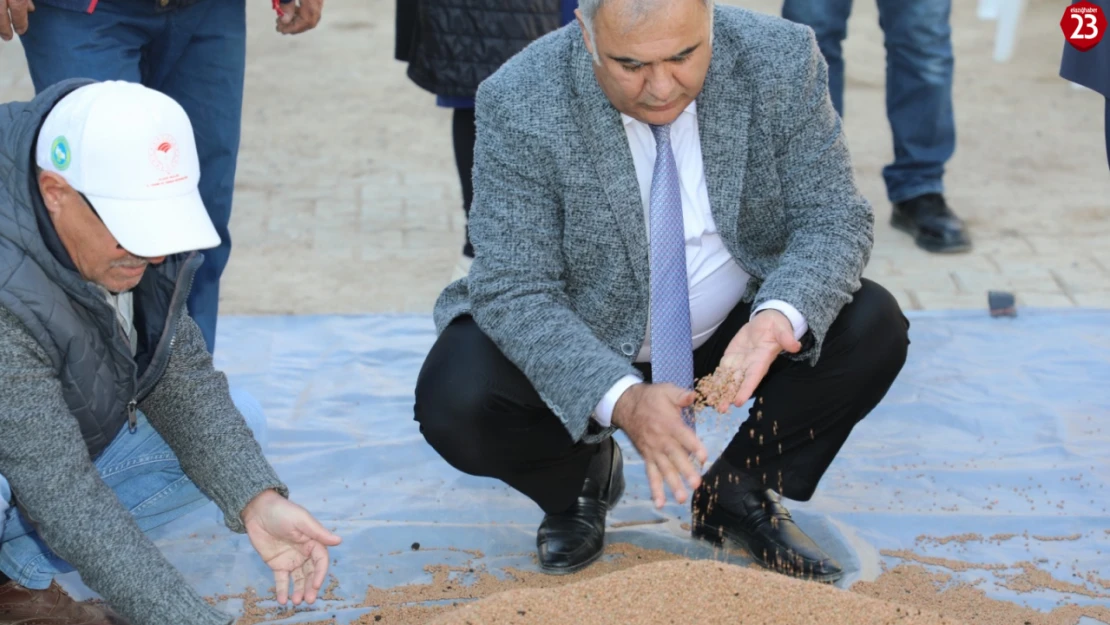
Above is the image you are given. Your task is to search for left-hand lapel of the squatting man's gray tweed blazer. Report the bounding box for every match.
[574,40,649,289]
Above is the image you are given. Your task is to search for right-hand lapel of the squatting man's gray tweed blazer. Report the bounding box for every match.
[697,42,751,256]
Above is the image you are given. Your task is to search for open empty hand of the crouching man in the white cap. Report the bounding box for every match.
[242,491,341,605]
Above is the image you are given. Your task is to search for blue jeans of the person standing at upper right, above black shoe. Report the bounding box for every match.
[783,0,956,203]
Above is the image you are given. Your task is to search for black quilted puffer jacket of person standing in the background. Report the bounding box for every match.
[394,0,561,98]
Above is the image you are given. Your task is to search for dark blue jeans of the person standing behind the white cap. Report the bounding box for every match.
[20,0,246,352]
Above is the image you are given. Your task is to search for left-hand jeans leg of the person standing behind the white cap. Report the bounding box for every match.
[20,2,150,92]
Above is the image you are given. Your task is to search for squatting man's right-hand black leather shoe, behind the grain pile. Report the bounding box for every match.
[690,458,844,582]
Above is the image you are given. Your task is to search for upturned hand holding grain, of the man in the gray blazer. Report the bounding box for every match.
[714,309,801,413]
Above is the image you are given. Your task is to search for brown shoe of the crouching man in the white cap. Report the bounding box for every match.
[0,582,128,625]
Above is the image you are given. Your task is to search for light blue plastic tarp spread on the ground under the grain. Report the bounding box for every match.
[56,310,1110,623]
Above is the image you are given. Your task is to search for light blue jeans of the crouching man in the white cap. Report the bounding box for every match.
[0,390,266,589]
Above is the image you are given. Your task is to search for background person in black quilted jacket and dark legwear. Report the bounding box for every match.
[394,0,578,280]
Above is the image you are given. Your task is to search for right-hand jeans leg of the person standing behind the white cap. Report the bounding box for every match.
[145,0,246,352]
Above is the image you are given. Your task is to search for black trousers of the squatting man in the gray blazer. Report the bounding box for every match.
[415,279,909,513]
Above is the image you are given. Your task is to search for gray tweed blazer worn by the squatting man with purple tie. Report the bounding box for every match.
[434,7,874,441]
